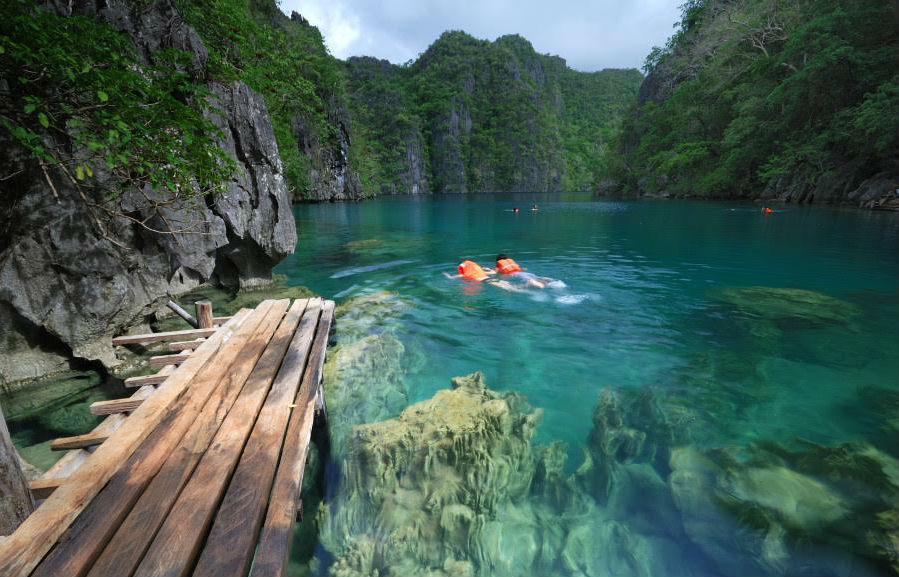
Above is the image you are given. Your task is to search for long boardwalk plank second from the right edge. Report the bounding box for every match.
[193,299,322,577]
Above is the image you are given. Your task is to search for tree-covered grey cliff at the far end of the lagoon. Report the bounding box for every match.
[346,32,641,192]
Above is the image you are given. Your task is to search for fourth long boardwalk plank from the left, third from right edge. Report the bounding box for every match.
[128,302,314,577]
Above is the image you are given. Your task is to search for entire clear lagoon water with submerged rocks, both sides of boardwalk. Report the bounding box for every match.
[3,194,899,577]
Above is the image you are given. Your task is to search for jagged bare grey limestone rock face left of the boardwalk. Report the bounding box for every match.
[0,0,296,382]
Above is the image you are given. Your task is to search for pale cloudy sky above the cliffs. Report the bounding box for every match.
[281,0,684,70]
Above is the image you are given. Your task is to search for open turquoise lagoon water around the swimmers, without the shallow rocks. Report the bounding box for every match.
[276,194,899,574]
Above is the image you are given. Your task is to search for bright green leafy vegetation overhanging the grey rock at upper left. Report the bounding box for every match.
[0,0,234,205]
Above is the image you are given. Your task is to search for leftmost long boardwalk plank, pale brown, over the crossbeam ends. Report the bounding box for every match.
[0,310,253,577]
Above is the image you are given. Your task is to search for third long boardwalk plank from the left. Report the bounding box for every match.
[88,301,305,577]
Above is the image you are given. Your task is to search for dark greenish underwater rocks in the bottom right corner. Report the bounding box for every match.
[668,442,899,575]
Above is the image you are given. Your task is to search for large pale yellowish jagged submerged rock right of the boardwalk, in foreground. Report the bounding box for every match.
[322,373,541,575]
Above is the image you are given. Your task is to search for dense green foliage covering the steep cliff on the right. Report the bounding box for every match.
[612,0,899,201]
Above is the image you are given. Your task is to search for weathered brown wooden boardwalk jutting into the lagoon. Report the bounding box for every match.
[0,298,334,577]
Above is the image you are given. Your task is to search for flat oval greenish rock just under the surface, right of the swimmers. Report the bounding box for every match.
[719,287,860,323]
